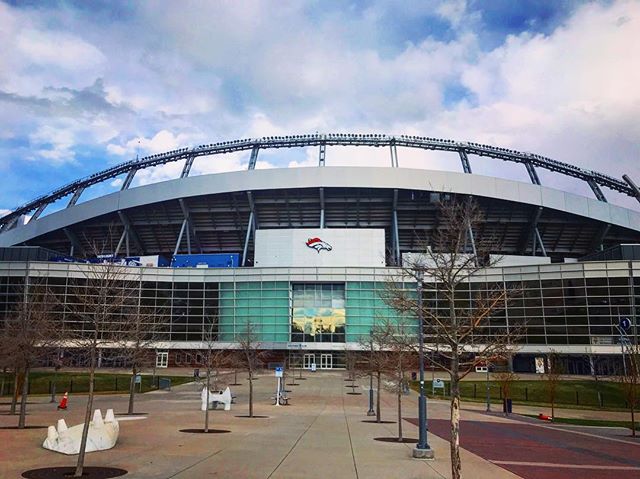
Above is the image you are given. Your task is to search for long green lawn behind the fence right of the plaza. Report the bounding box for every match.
[413,380,627,409]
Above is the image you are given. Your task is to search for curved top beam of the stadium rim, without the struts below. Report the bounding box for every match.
[0,134,637,224]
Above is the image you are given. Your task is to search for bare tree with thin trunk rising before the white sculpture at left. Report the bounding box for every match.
[62,263,140,477]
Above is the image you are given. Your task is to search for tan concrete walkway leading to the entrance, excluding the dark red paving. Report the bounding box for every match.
[0,372,517,479]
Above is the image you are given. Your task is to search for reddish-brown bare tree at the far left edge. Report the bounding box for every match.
[0,278,59,429]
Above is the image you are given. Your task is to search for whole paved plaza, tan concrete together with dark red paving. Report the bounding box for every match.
[0,372,640,479]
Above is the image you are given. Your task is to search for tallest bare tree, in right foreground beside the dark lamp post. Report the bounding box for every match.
[383,199,519,479]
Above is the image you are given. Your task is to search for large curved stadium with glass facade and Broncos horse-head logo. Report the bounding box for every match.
[0,134,640,374]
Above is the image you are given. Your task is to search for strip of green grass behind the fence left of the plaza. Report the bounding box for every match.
[0,371,193,396]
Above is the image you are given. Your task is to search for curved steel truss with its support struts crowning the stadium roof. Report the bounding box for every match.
[0,133,640,230]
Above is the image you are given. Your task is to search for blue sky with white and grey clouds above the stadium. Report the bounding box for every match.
[0,0,640,213]
